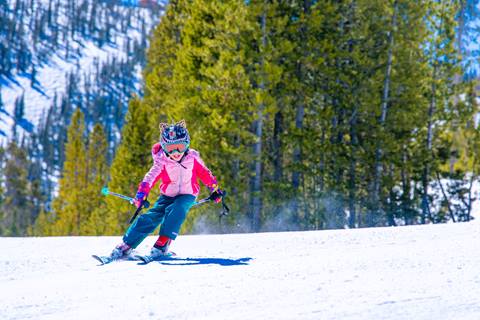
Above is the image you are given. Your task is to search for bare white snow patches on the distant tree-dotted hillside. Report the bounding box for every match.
[0,0,163,142]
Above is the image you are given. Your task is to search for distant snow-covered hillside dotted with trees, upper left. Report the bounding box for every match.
[0,0,164,141]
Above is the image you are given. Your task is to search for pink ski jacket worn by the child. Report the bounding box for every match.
[142,145,217,197]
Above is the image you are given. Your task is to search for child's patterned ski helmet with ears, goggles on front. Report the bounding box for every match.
[160,120,190,154]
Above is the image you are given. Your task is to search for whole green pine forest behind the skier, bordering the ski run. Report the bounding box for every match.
[0,0,480,236]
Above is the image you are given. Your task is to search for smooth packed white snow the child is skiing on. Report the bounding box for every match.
[0,220,480,320]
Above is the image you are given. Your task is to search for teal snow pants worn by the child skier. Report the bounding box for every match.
[123,194,195,248]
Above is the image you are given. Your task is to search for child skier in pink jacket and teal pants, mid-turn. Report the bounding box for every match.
[111,120,223,259]
